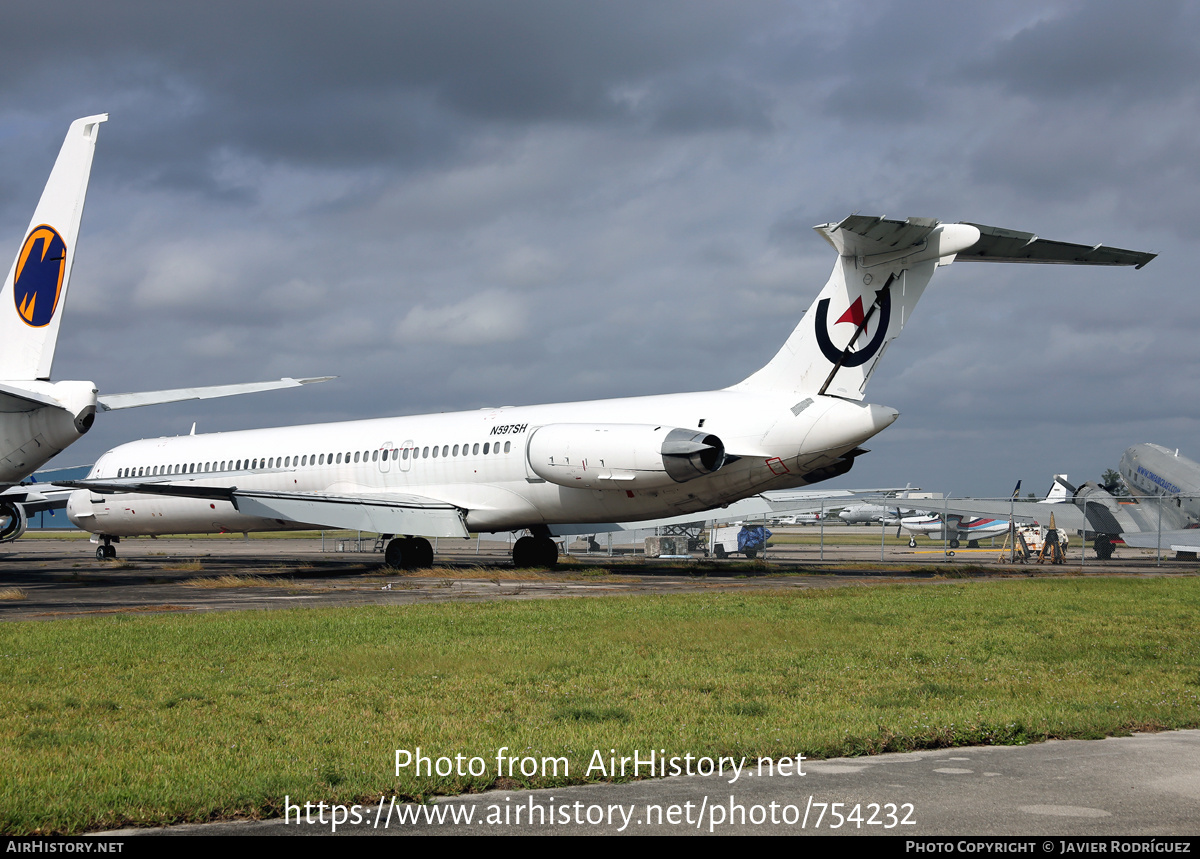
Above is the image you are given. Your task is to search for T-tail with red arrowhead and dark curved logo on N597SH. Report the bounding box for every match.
[731,215,1154,400]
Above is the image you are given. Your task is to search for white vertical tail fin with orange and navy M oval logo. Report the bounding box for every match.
[0,114,108,380]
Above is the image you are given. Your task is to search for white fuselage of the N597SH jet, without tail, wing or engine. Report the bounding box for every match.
[67,390,896,536]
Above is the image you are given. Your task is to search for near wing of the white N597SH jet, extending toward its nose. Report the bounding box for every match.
[59,480,469,537]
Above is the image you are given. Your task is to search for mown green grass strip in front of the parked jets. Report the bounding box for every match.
[0,577,1200,834]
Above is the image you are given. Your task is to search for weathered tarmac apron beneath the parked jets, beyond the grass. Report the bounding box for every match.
[0,537,1198,620]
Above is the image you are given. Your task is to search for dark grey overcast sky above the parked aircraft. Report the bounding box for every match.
[0,0,1200,495]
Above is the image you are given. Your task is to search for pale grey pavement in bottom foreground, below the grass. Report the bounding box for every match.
[103,731,1200,835]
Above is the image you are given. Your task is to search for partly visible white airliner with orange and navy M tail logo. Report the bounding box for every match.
[0,114,330,542]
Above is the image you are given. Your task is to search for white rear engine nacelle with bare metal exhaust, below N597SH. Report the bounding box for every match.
[527,424,725,489]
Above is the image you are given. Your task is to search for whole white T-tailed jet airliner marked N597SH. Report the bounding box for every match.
[58,215,1154,566]
